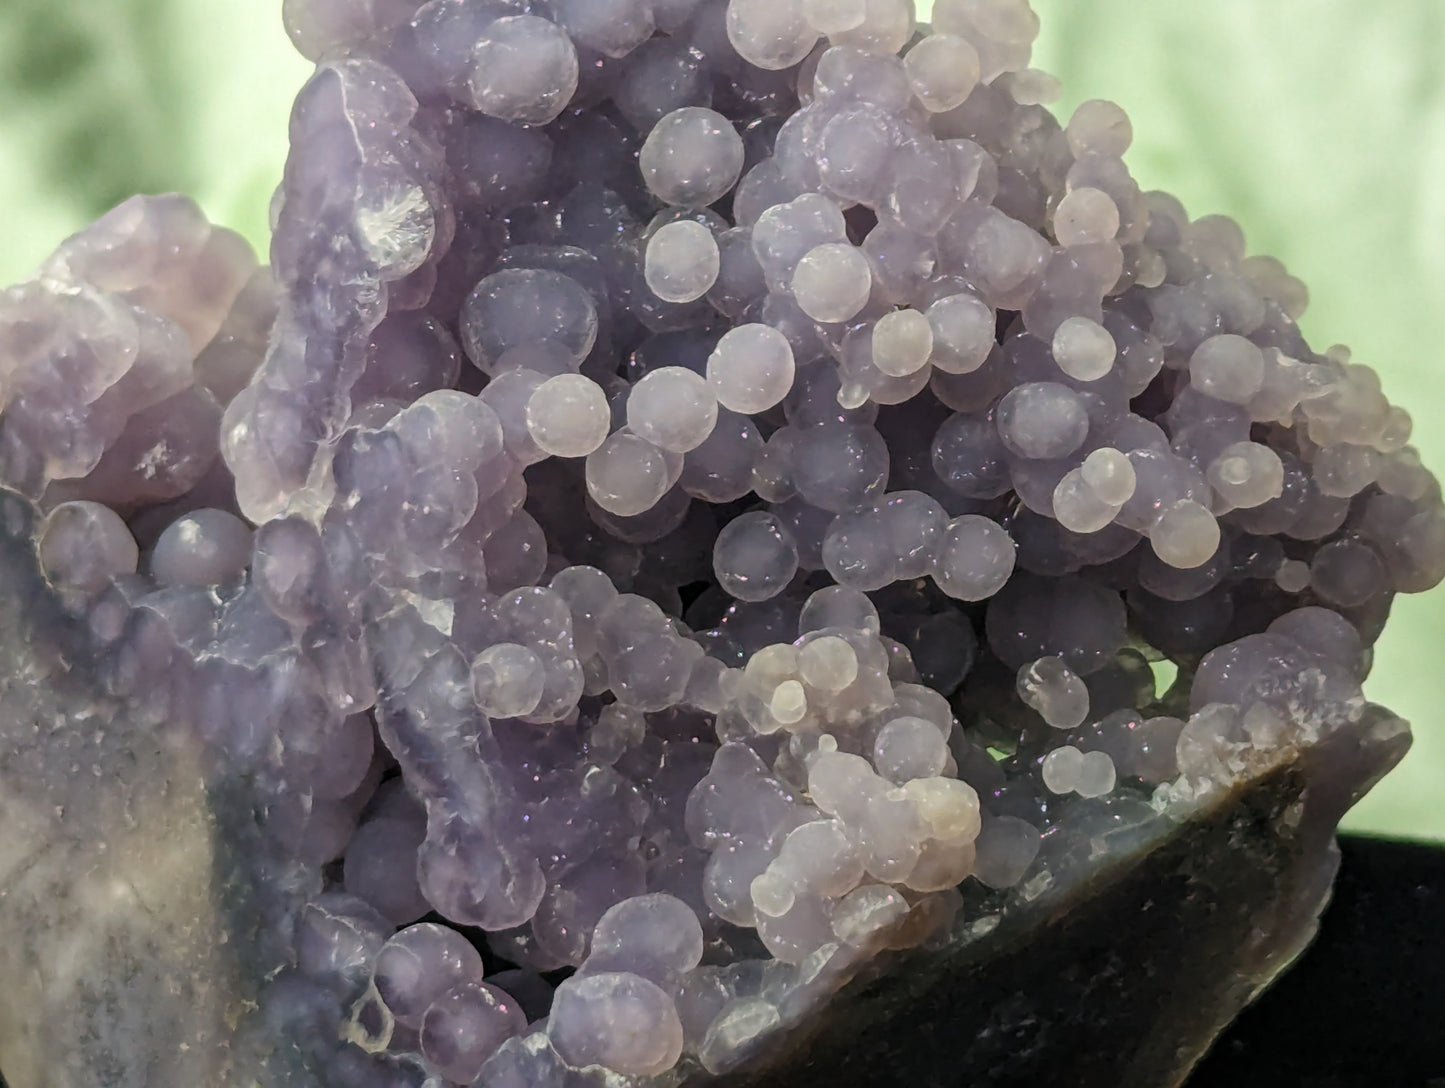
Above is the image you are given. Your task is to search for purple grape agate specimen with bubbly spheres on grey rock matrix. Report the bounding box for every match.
[0,0,1445,1088]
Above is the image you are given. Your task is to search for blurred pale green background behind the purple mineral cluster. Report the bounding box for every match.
[0,0,1445,841]
